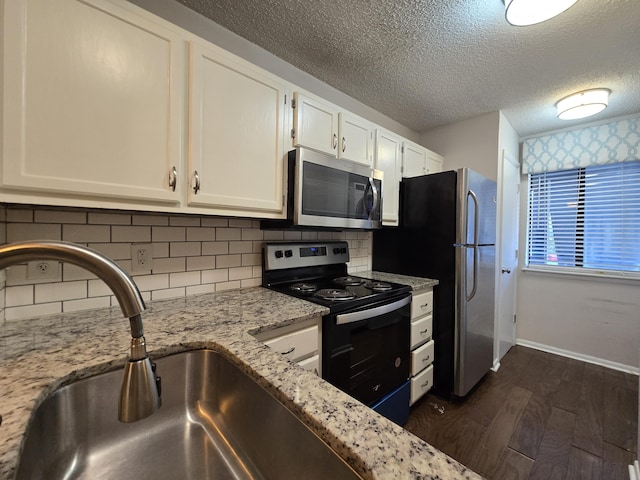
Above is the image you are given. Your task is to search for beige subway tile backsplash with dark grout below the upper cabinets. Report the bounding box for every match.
[0,205,372,321]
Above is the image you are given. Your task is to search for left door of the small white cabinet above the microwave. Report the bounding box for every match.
[293,92,339,155]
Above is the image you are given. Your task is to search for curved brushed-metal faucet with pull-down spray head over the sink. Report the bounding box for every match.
[0,240,160,423]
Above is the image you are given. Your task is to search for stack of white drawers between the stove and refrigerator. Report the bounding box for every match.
[409,288,435,405]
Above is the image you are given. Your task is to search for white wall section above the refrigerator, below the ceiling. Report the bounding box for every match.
[420,112,501,180]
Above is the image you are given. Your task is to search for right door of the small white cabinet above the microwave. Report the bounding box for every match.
[338,112,373,167]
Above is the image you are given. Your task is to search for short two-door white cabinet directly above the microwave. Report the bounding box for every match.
[293,92,374,166]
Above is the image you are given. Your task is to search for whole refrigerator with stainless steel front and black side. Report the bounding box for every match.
[373,168,496,397]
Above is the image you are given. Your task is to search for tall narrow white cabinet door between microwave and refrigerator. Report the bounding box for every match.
[375,129,402,225]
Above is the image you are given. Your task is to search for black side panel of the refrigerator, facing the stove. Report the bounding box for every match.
[372,171,457,396]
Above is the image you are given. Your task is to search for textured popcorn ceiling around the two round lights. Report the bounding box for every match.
[178,0,640,136]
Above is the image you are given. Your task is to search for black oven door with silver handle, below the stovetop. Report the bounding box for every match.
[322,294,411,406]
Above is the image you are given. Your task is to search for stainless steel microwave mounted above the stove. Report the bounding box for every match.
[278,148,383,230]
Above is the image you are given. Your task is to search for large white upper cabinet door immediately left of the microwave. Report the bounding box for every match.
[188,42,286,217]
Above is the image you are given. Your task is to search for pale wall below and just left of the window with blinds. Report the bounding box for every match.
[517,201,640,373]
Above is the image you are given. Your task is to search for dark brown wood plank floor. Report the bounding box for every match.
[405,346,638,480]
